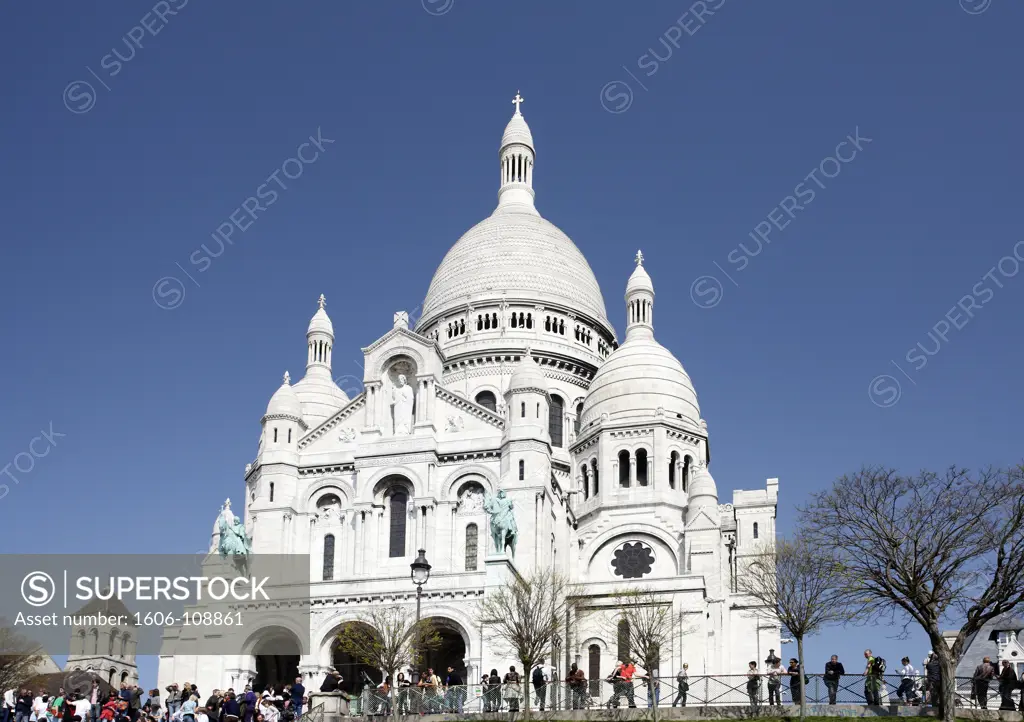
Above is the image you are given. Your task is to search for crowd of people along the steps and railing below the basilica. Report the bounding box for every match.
[8,649,1024,722]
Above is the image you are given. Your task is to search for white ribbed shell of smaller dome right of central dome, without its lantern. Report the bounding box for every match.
[581,336,700,429]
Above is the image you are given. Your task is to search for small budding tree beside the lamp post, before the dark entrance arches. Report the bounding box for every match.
[338,605,441,719]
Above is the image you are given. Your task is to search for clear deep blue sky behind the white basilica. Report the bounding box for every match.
[0,0,1024,684]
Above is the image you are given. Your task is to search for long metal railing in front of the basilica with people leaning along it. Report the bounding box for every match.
[335,673,1020,717]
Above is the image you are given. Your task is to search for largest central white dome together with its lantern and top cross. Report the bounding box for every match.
[419,95,614,337]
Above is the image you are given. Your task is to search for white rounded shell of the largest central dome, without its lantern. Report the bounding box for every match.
[420,208,611,333]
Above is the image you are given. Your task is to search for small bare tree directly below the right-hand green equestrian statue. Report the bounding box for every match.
[479,568,570,717]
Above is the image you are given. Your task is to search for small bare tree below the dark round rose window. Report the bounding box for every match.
[607,587,673,720]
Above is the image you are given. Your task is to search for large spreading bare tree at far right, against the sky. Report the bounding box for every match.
[801,466,1024,722]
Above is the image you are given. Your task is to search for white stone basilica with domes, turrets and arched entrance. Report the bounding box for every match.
[158,94,780,695]
